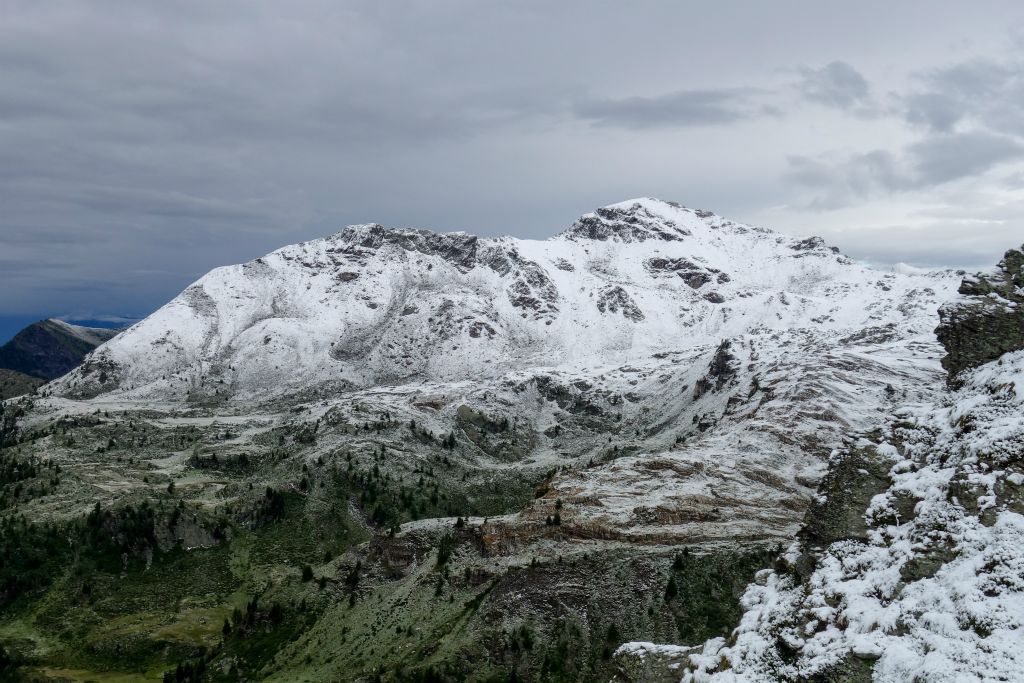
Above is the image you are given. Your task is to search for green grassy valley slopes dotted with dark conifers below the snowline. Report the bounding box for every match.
[0,403,771,681]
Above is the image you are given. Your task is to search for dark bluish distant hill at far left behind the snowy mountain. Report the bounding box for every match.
[0,318,120,383]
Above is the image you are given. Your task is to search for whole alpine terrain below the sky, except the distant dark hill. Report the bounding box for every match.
[0,199,1024,682]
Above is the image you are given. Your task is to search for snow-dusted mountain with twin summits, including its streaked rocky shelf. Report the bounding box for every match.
[37,199,961,544]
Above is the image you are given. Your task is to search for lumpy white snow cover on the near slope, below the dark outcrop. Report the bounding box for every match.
[671,351,1024,683]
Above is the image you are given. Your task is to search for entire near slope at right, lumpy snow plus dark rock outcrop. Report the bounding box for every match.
[618,248,1024,683]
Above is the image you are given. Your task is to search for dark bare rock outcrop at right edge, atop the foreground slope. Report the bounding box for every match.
[935,247,1024,381]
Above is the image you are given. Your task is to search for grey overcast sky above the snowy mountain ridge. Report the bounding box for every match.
[0,0,1024,331]
